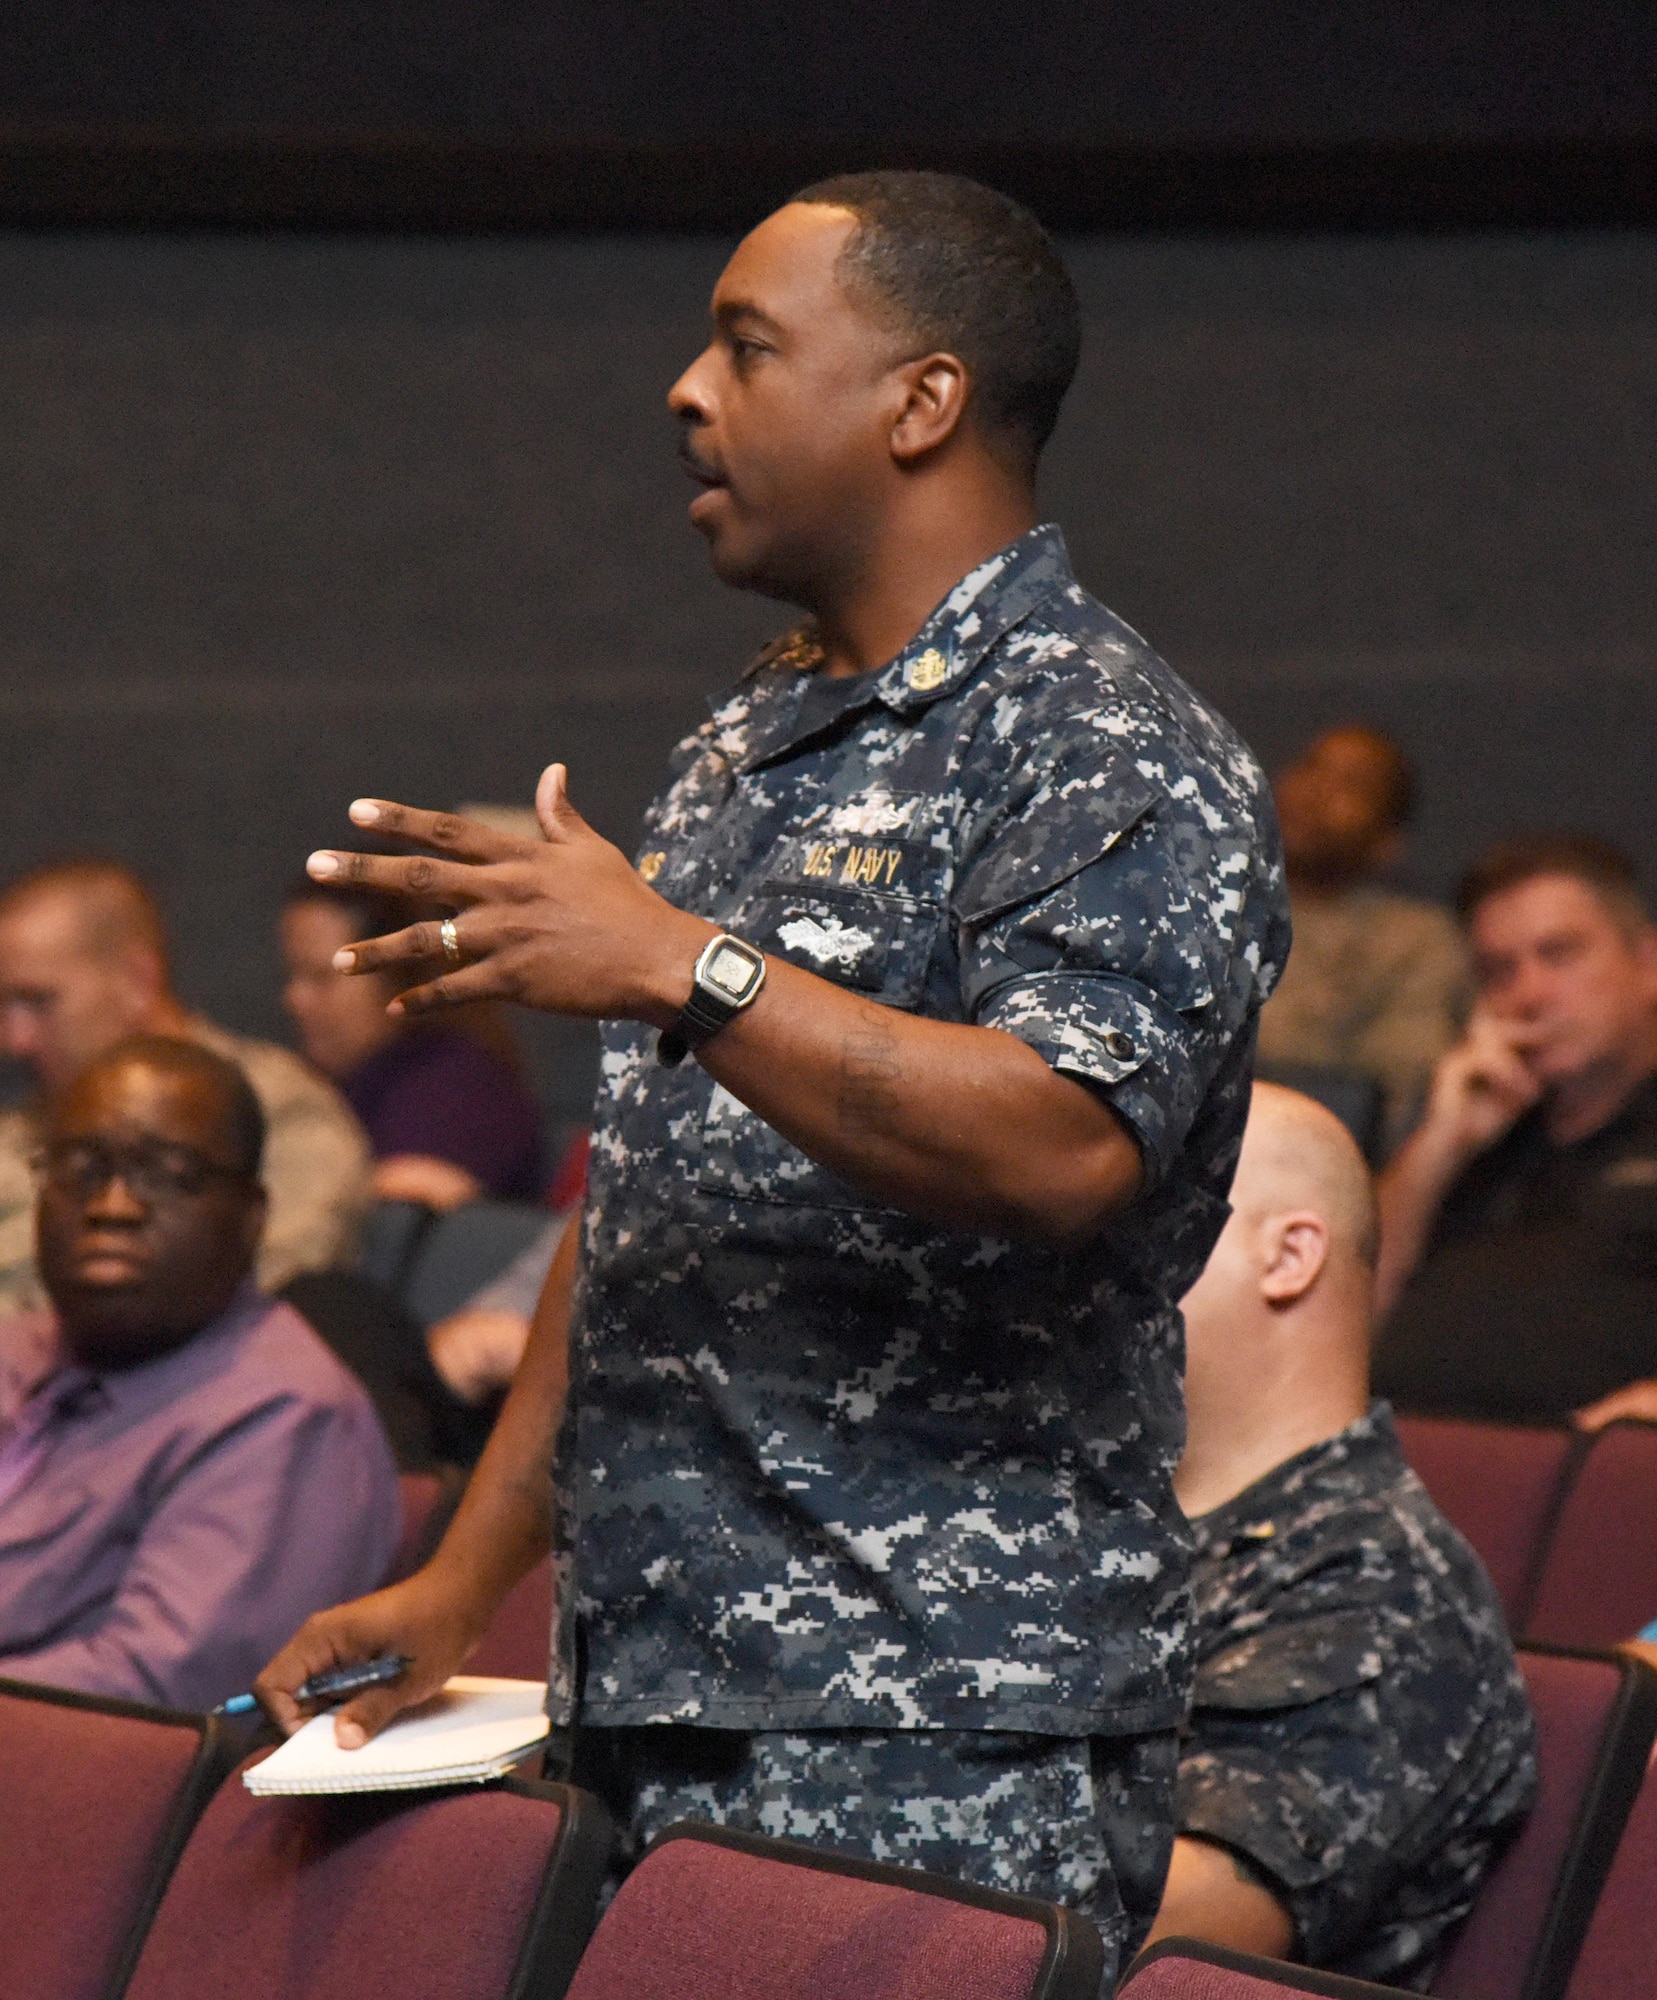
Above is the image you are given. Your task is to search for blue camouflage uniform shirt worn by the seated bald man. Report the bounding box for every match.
[1175,1404,1537,1986]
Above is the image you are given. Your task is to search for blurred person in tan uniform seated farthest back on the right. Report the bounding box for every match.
[1259,726,1467,1146]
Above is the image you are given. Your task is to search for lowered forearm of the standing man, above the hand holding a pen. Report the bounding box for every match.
[432,1228,580,1610]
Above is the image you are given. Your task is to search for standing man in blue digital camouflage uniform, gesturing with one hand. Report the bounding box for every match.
[264,174,1289,1984]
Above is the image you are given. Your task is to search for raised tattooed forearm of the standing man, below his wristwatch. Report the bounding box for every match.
[700,958,1141,1242]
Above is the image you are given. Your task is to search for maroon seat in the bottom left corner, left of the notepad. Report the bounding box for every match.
[0,1680,234,2000]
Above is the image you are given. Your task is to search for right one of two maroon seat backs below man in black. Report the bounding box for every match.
[1523,1424,1657,1646]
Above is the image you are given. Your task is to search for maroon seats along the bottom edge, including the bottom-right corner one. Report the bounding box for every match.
[0,1648,1657,2000]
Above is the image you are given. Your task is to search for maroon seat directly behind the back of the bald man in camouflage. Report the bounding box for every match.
[1431,1648,1657,2000]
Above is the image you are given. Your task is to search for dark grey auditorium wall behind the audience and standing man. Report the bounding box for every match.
[0,0,1657,1116]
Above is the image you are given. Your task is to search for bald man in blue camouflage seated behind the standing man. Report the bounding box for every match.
[1153,1084,1537,1986]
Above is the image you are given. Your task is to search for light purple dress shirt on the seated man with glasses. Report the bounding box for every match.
[0,1288,400,1708]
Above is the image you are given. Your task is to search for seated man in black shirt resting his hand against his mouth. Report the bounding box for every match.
[1377,834,1657,1422]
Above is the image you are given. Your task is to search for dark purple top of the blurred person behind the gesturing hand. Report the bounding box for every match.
[340,1028,544,1202]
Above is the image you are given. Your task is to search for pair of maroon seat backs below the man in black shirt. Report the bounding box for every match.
[1399,1416,1657,1648]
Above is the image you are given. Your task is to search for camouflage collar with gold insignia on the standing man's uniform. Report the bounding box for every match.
[738,522,1075,770]
